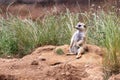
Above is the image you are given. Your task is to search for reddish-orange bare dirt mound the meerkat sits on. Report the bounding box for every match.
[0,45,103,80]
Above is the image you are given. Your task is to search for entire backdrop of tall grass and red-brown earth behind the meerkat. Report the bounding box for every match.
[0,0,120,79]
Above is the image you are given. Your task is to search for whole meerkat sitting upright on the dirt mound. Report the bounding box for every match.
[69,22,86,59]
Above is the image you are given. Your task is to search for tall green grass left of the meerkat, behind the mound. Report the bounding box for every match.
[0,11,78,56]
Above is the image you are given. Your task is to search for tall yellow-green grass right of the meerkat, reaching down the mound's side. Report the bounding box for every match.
[85,11,120,80]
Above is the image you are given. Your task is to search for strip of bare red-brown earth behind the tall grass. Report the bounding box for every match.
[0,0,120,20]
